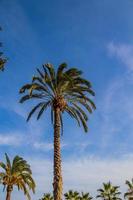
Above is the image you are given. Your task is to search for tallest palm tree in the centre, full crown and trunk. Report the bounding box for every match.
[20,63,95,200]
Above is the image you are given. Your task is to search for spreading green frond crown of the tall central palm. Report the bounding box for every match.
[20,63,96,132]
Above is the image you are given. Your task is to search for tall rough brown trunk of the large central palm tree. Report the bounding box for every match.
[53,108,63,200]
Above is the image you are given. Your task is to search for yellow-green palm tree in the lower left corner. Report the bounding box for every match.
[0,154,35,200]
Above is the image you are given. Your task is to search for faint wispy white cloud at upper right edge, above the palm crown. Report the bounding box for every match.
[107,42,133,70]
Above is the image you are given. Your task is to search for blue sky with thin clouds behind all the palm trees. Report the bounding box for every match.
[0,0,133,200]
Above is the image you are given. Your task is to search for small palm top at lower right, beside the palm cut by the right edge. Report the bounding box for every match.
[96,182,121,200]
